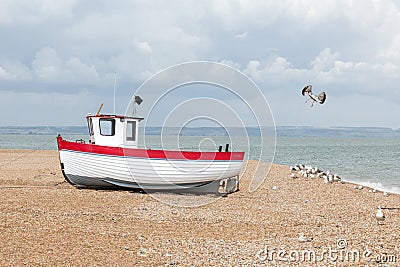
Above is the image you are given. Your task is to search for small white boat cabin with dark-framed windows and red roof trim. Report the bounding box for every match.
[86,114,143,148]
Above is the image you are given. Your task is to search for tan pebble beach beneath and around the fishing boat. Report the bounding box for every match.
[0,149,400,266]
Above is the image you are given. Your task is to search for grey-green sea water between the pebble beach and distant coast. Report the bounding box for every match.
[0,135,400,194]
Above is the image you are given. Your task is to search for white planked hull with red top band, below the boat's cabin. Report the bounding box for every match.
[57,137,244,190]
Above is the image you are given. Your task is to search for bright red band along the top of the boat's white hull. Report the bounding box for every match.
[57,136,244,160]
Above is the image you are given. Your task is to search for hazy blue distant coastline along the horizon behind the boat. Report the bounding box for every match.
[0,126,400,138]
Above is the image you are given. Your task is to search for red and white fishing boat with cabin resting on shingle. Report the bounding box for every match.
[57,102,244,193]
